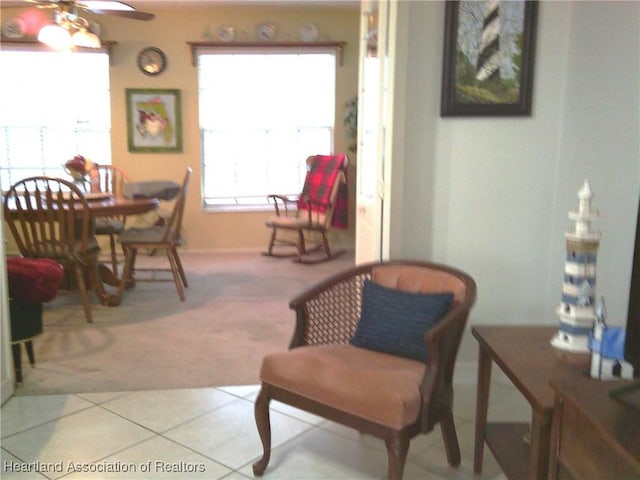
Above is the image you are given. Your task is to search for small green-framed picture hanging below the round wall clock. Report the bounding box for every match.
[126,88,182,153]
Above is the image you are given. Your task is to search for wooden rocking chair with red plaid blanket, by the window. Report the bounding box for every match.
[265,154,349,264]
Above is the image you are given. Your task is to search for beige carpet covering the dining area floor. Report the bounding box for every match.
[16,252,354,395]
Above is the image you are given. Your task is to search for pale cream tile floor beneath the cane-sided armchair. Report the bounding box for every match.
[0,383,530,480]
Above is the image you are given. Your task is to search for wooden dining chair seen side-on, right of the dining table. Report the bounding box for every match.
[118,168,192,302]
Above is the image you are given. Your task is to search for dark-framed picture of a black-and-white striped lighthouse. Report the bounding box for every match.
[440,0,538,117]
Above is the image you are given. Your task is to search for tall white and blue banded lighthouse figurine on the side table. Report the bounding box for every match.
[551,180,600,353]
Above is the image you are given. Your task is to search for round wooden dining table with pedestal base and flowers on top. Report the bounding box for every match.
[9,194,159,307]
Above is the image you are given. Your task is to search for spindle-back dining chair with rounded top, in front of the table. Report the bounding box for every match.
[4,177,100,323]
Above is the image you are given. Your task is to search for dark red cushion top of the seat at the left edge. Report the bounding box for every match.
[7,257,64,303]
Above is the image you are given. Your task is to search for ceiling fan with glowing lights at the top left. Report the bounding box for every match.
[4,0,155,50]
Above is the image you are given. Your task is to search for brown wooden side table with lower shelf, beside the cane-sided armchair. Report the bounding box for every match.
[471,326,590,480]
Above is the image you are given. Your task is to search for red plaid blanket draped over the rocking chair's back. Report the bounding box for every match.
[298,154,348,228]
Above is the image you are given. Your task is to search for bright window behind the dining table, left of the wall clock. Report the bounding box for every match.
[0,47,111,190]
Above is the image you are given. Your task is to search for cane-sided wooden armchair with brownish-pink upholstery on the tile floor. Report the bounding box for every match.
[253,261,476,480]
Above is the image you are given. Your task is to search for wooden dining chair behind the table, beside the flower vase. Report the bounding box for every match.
[90,164,130,277]
